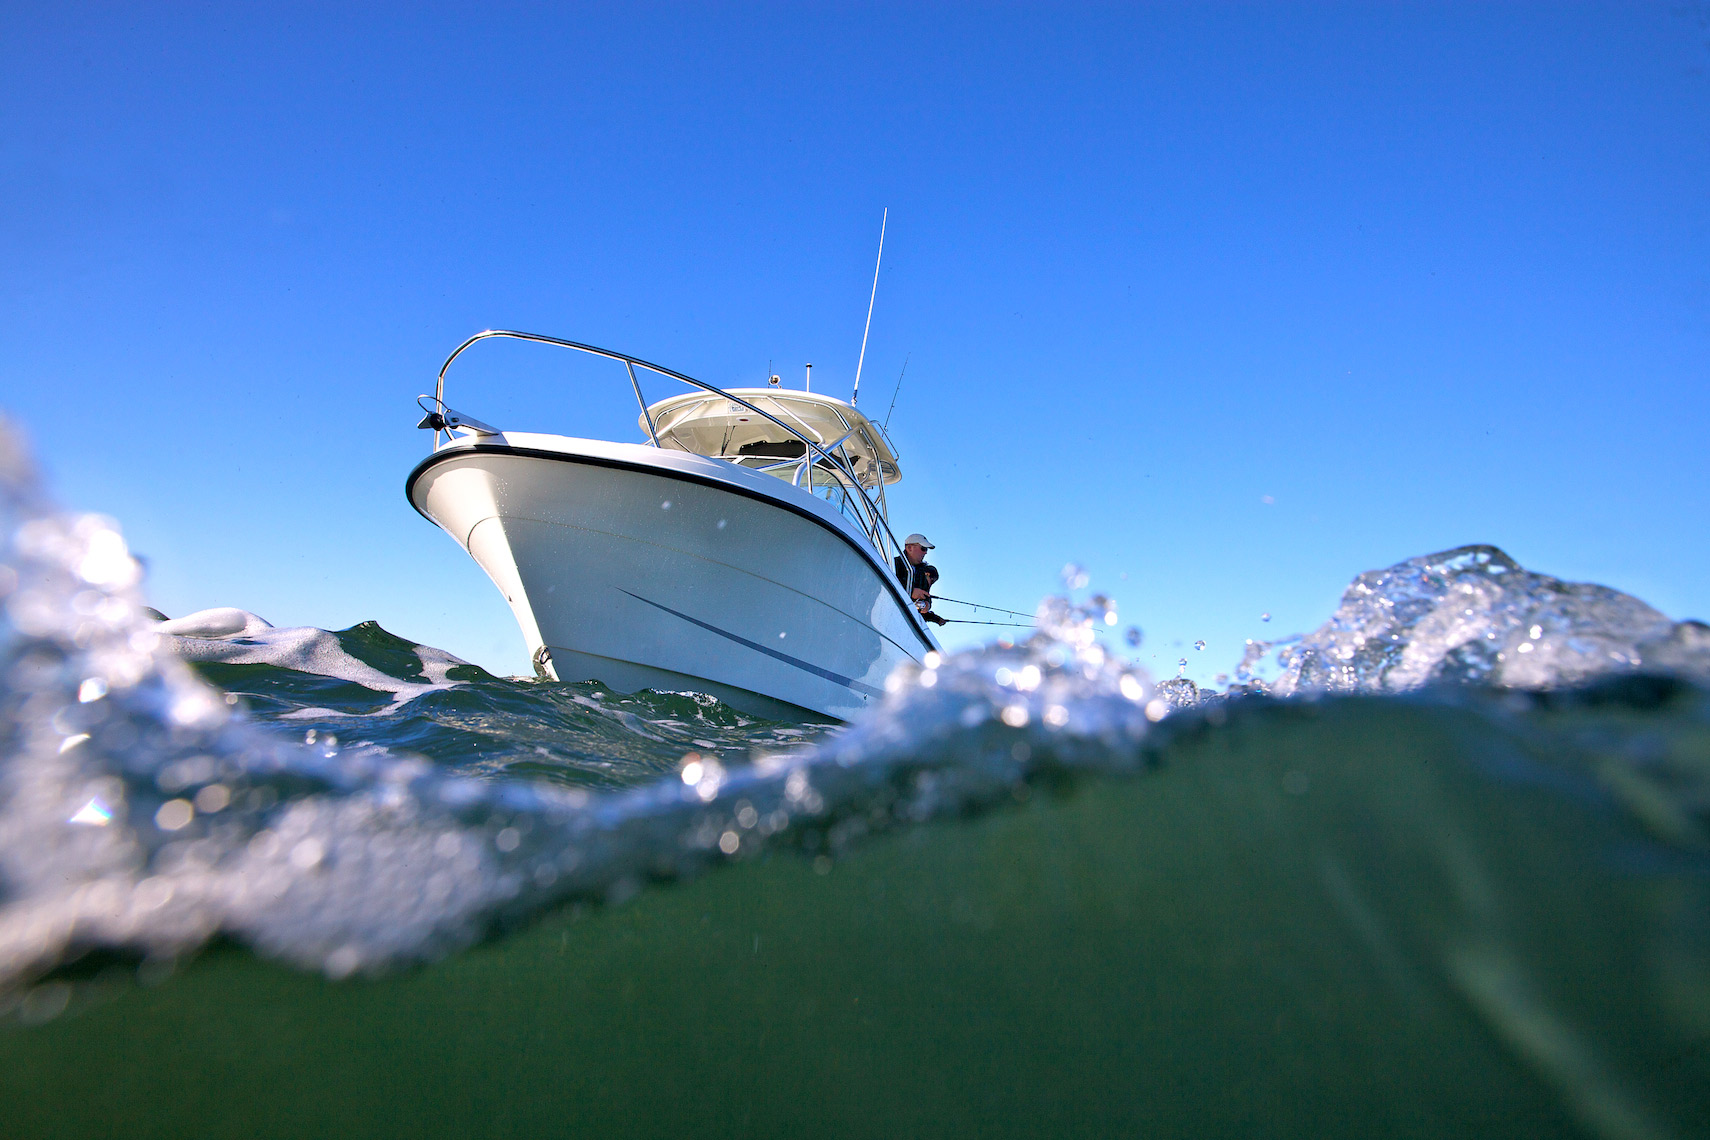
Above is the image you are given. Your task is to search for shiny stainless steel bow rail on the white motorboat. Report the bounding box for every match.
[416,328,903,574]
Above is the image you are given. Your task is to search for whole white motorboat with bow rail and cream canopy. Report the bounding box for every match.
[405,330,937,720]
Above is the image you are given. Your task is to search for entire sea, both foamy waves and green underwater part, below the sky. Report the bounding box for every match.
[0,422,1710,1138]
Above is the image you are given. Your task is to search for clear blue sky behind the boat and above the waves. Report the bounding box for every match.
[0,0,1710,679]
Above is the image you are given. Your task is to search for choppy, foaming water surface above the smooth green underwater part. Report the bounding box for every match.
[0,405,1710,986]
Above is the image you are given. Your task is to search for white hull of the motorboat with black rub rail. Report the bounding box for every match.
[407,432,935,720]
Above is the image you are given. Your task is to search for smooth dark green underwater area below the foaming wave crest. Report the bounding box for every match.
[0,690,1710,1140]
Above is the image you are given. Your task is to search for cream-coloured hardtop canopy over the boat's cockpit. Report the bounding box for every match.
[636,388,903,487]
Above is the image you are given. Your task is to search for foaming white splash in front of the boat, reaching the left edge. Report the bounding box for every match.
[0,427,1156,991]
